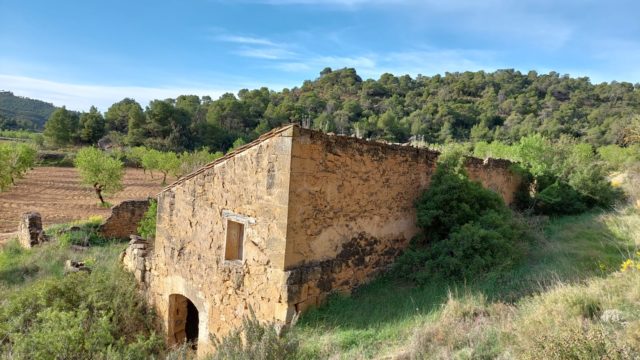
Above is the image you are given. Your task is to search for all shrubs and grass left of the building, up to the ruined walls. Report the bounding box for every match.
[0,218,163,359]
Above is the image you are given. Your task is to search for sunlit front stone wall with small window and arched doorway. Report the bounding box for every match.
[147,128,292,353]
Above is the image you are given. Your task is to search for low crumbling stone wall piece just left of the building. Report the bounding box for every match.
[99,200,149,239]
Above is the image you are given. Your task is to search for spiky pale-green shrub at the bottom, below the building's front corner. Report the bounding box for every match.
[210,310,298,360]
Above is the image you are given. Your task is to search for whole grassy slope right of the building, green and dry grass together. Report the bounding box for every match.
[293,209,640,359]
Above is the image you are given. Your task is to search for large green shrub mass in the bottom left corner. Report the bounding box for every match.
[0,268,162,359]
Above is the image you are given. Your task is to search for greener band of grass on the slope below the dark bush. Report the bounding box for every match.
[293,208,640,358]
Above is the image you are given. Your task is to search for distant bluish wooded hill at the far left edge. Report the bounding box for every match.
[0,91,56,130]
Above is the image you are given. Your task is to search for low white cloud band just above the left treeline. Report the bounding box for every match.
[0,74,228,111]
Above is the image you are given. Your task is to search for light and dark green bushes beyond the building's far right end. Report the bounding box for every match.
[474,134,624,214]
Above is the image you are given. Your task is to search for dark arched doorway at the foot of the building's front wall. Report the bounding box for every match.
[168,294,200,349]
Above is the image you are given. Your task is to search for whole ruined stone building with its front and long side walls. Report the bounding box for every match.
[127,125,520,353]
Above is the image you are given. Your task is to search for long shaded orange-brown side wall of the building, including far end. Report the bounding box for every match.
[285,128,520,311]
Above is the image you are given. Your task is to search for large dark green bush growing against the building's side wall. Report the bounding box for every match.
[394,160,527,283]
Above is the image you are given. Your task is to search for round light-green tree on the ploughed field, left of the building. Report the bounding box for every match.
[74,147,124,205]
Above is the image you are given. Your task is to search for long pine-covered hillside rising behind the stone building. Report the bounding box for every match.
[41,68,640,150]
